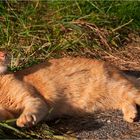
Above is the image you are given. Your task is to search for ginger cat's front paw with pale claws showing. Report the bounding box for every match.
[16,113,37,127]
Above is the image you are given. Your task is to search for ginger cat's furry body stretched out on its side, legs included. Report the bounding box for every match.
[0,52,140,127]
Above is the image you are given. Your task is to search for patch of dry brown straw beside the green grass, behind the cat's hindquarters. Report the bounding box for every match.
[101,34,140,71]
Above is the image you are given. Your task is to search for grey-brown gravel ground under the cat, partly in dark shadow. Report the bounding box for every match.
[48,108,140,139]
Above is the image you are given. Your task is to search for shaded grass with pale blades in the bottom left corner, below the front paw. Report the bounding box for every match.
[0,120,65,139]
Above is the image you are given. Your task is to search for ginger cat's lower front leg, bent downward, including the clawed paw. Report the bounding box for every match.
[16,98,48,127]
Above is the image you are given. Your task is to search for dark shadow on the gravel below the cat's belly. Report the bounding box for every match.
[46,114,104,133]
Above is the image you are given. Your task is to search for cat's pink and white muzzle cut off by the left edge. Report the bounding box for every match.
[0,51,9,74]
